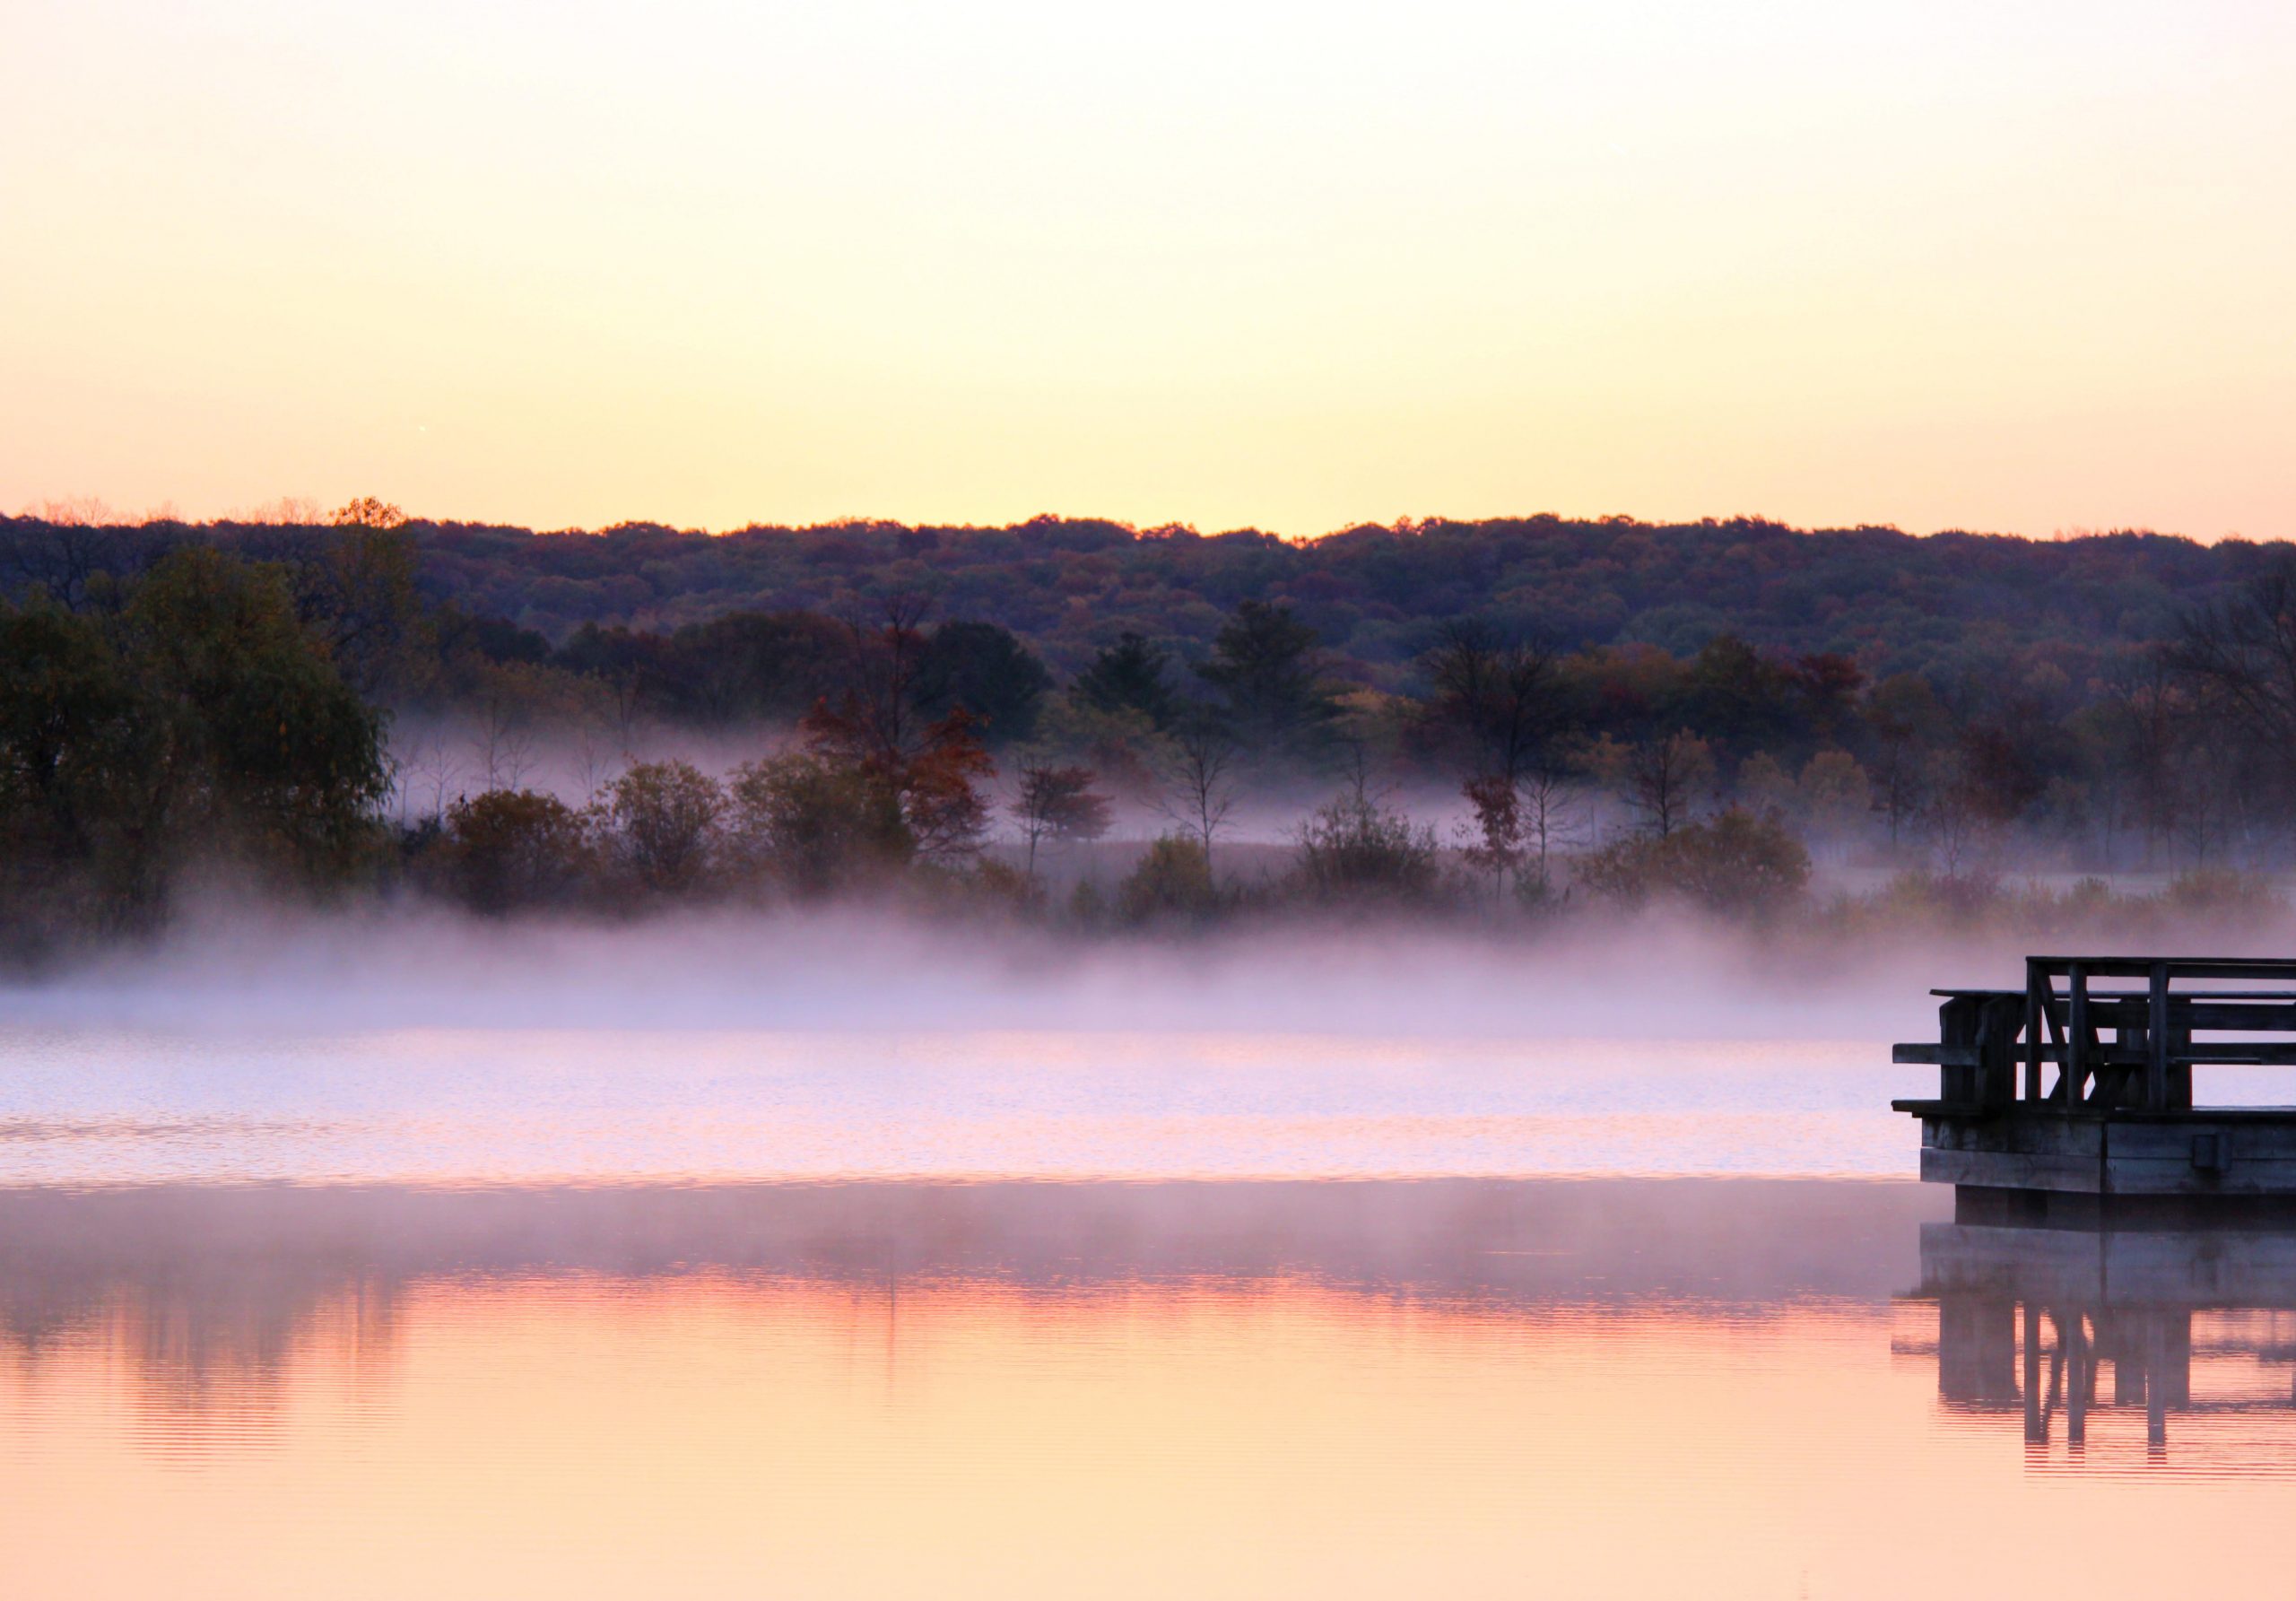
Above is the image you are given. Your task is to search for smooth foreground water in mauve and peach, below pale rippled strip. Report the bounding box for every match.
[0,1180,2287,1601]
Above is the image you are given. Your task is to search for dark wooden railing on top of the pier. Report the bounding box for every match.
[1894,955,2296,1114]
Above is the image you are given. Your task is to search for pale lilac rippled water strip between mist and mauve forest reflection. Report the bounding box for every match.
[0,1029,1935,1183]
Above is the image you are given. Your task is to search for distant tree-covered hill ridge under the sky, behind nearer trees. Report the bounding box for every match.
[0,517,2271,692]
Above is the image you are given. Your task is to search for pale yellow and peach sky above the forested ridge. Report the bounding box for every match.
[0,0,2296,537]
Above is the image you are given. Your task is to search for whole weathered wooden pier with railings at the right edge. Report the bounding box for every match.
[1892,955,2296,1222]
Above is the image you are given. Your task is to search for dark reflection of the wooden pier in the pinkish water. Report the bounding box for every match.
[1918,1222,2296,1475]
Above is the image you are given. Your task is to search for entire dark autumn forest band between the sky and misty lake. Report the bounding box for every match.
[0,500,2296,953]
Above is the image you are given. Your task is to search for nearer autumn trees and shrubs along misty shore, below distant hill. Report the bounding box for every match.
[0,503,2296,944]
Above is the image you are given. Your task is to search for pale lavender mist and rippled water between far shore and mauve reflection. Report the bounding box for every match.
[0,914,1922,1183]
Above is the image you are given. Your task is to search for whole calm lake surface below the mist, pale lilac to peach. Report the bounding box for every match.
[0,1031,2296,1601]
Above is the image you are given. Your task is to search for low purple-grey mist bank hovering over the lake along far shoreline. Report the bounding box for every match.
[0,905,1983,1040]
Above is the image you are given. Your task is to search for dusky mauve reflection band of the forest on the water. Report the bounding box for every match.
[0,1180,1938,1404]
